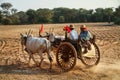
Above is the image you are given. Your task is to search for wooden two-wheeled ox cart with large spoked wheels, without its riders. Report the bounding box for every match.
[56,35,100,71]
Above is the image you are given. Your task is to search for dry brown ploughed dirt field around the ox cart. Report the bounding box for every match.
[0,23,120,80]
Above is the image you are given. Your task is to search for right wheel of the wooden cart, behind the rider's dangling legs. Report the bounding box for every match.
[80,43,100,67]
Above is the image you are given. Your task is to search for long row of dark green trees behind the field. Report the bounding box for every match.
[0,3,120,25]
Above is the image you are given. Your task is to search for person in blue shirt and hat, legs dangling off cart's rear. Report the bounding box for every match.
[79,25,92,53]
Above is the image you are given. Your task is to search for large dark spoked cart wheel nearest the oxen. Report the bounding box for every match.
[56,42,77,72]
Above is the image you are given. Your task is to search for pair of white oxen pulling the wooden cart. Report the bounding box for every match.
[20,30,64,70]
